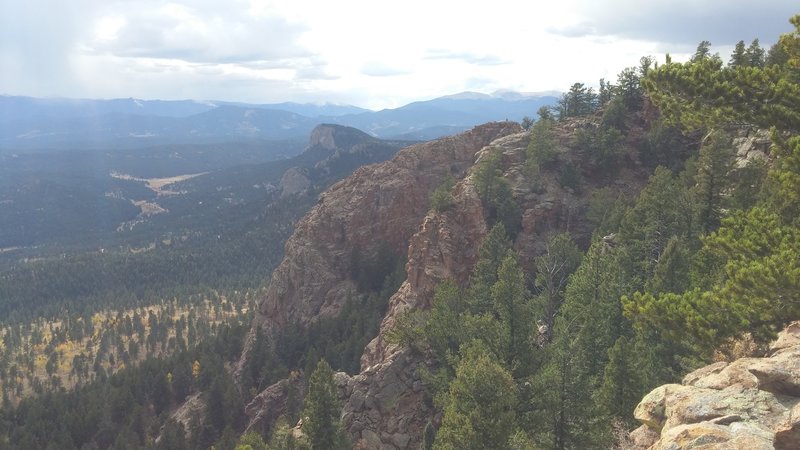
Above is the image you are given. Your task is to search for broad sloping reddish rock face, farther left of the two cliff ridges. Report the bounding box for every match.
[240,122,521,367]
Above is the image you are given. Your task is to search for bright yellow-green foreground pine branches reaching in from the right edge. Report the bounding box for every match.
[623,15,800,348]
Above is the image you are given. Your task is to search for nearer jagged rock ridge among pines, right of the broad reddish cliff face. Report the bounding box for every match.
[337,118,635,449]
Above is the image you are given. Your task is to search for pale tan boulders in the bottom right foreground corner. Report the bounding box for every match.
[631,322,800,450]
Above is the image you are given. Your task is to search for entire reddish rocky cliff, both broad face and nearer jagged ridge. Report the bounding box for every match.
[240,118,644,449]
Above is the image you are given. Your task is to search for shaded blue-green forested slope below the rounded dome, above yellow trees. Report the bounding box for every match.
[0,125,405,318]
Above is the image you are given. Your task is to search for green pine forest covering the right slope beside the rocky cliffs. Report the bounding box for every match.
[400,17,800,449]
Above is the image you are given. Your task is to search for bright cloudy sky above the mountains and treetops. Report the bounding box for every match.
[0,0,800,109]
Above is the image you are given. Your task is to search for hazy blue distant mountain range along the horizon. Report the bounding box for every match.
[0,91,557,149]
